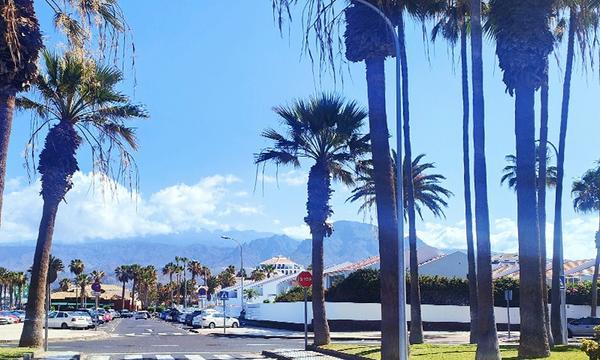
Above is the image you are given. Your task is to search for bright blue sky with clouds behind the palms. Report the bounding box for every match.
[0,0,600,257]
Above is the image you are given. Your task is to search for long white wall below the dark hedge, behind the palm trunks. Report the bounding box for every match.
[246,302,590,324]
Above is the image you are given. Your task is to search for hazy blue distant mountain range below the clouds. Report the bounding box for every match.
[0,221,441,282]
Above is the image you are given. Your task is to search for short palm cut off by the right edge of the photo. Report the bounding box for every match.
[571,166,600,317]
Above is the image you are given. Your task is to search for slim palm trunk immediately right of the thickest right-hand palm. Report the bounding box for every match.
[537,64,554,347]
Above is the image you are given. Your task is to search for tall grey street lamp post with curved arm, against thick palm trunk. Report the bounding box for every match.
[353,0,408,360]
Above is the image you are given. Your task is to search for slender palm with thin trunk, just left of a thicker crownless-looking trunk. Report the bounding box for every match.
[431,0,478,344]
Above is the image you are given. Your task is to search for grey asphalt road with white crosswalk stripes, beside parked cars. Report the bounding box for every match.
[49,319,303,360]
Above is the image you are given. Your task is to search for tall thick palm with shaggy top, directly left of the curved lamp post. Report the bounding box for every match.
[344,3,400,359]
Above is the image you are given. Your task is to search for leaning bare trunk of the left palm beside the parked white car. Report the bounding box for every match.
[19,199,59,348]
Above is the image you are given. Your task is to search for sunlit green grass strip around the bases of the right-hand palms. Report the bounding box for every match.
[322,344,588,360]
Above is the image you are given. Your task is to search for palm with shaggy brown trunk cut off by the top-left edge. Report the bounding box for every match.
[0,0,43,229]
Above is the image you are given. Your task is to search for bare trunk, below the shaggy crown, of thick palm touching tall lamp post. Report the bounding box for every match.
[365,56,400,359]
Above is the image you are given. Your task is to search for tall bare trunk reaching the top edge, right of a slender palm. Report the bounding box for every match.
[471,0,500,360]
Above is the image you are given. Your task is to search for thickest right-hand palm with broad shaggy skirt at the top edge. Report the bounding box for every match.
[490,0,554,358]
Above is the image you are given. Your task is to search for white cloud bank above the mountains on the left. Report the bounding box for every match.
[0,173,261,242]
